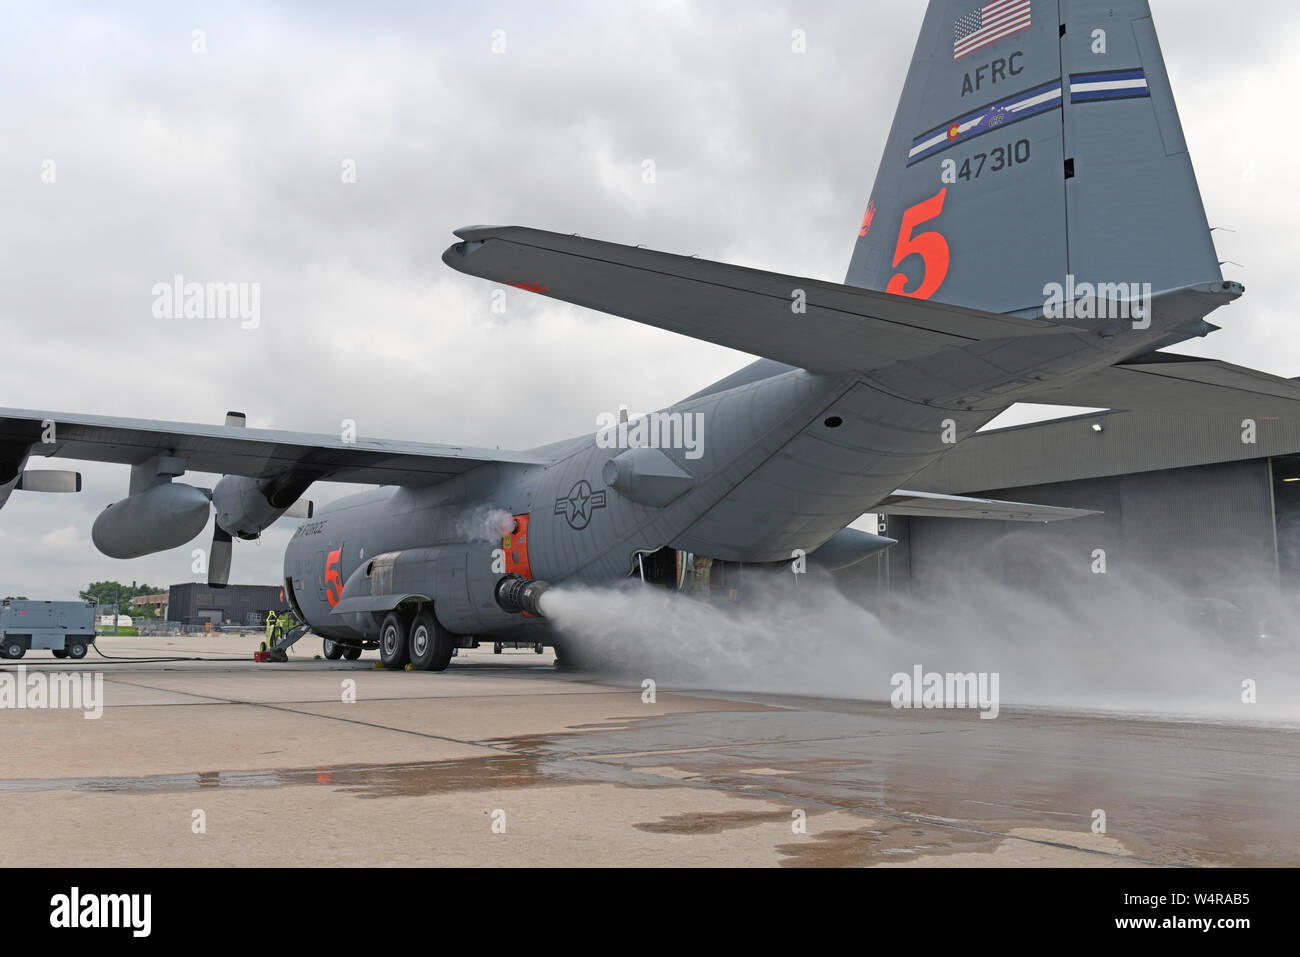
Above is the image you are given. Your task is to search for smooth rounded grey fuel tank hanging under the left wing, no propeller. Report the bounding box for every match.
[90,482,208,558]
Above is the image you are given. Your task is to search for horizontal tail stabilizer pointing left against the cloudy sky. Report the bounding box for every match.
[442,226,1078,372]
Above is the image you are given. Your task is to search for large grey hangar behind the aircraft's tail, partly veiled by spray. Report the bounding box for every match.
[868,411,1300,601]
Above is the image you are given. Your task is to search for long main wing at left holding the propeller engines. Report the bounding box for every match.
[0,408,545,486]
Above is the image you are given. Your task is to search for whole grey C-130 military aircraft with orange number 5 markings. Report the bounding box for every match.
[0,0,1300,670]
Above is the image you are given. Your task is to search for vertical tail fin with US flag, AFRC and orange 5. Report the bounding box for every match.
[845,0,1222,315]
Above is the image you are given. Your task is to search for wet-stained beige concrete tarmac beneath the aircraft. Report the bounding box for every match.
[0,636,1300,867]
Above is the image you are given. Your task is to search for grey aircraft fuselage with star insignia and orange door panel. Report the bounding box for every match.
[285,282,1225,638]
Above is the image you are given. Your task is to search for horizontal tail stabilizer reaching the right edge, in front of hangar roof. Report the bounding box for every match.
[1023,352,1300,416]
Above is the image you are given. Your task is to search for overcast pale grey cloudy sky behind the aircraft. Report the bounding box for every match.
[0,0,1300,598]
